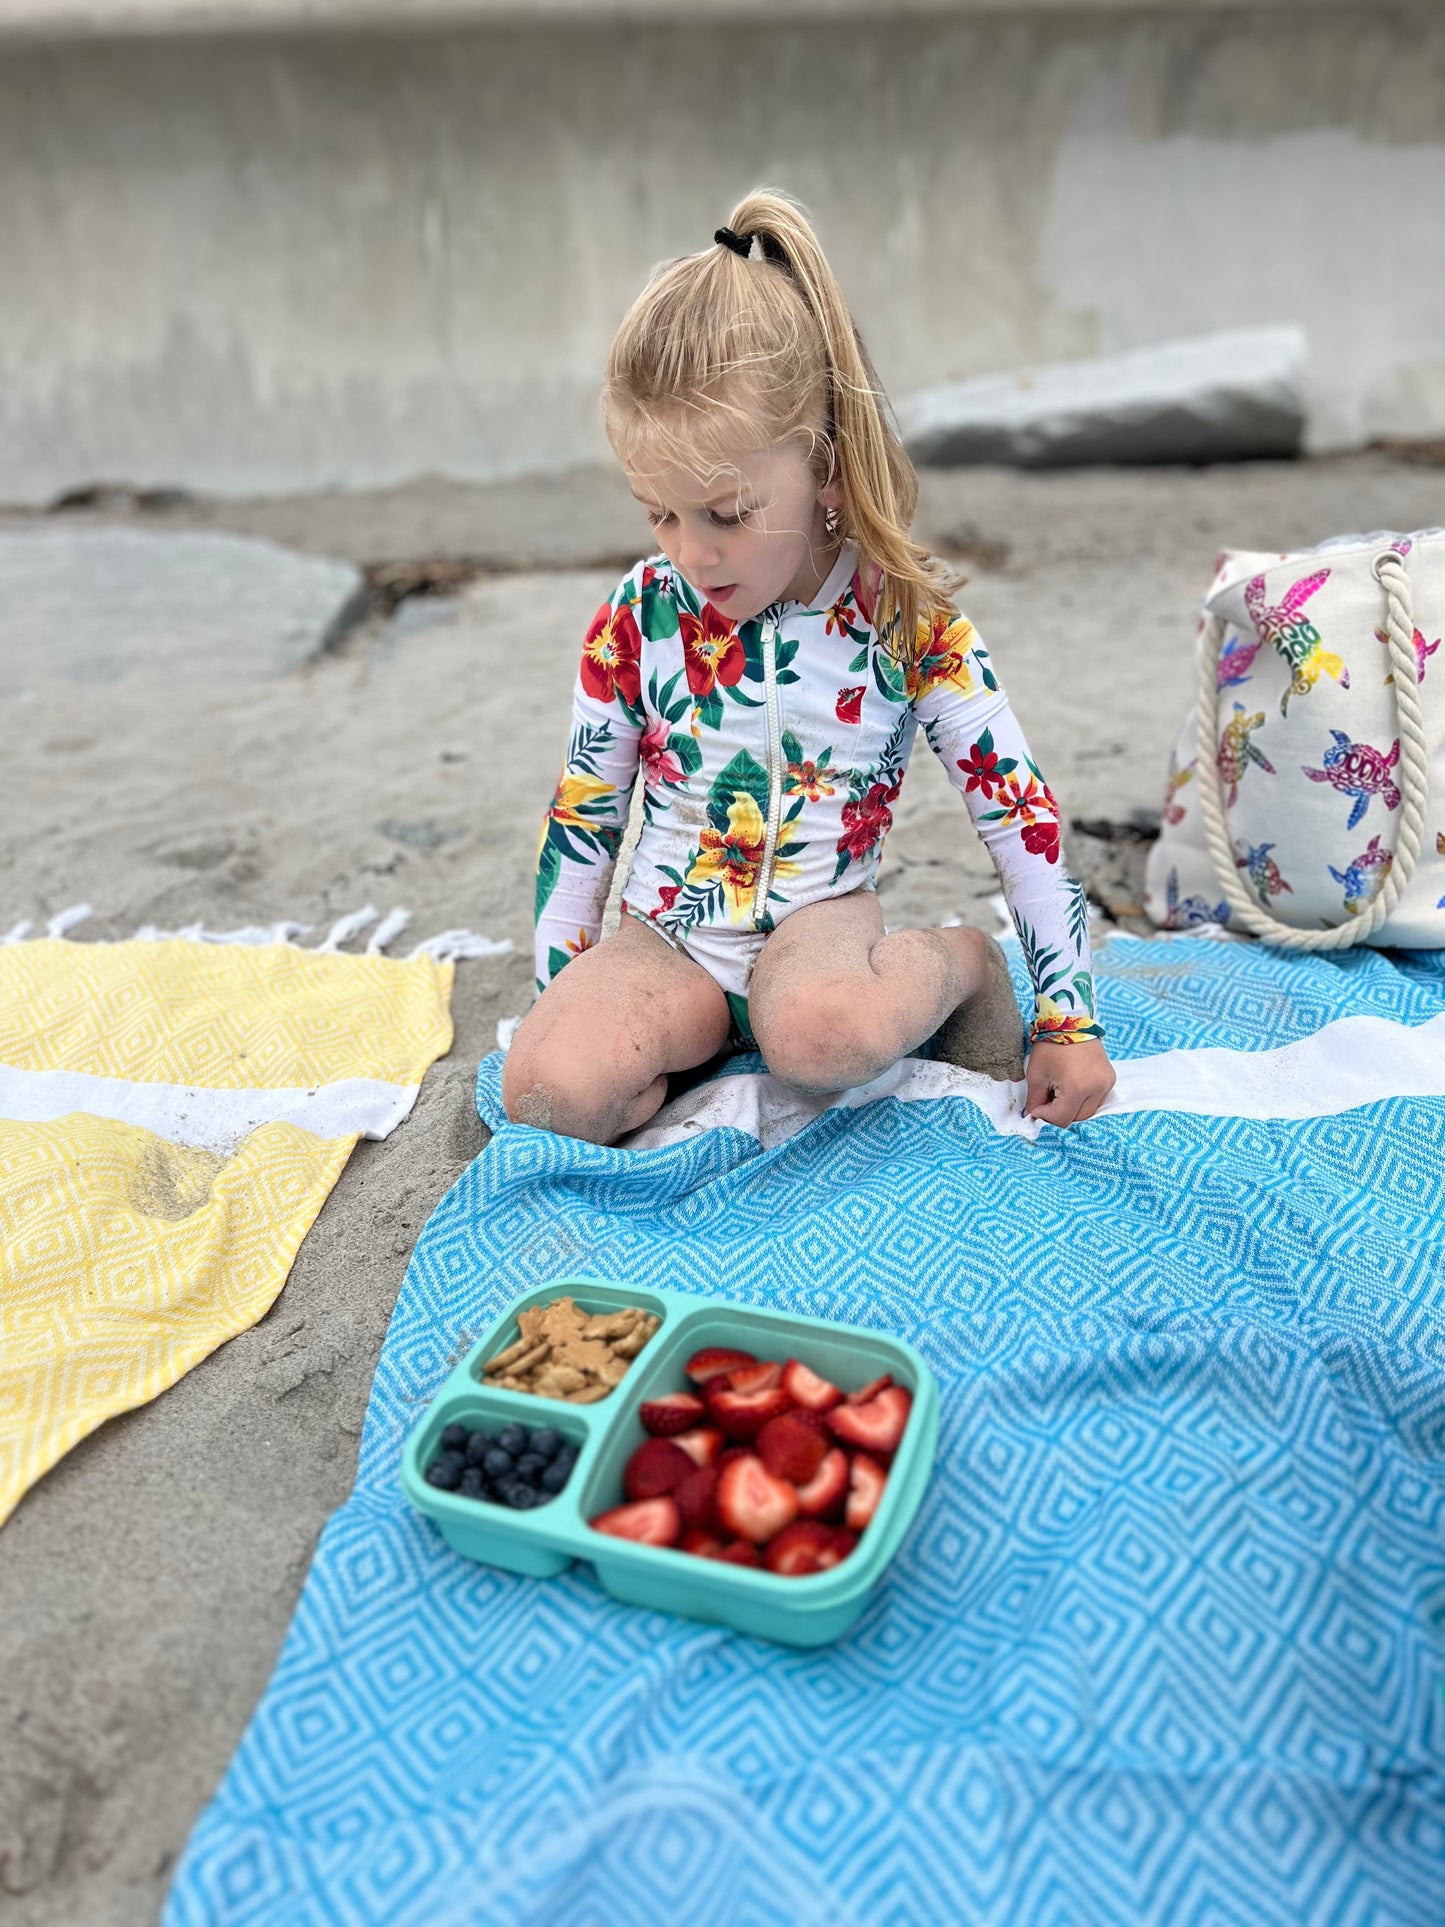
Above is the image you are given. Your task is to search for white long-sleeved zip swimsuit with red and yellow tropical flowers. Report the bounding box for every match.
[536,543,1104,1043]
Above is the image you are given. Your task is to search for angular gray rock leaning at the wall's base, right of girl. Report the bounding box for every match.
[898,328,1306,468]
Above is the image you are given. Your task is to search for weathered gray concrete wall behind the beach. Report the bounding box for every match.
[0,0,1445,503]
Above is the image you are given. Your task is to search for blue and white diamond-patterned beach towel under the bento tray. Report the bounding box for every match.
[166,938,1445,1927]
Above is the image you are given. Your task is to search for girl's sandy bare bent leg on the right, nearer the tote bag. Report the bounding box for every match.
[748,890,986,1091]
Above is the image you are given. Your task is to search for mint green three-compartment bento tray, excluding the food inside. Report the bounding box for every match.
[401,1278,938,1646]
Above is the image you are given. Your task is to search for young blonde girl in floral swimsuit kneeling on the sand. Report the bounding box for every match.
[503,189,1114,1143]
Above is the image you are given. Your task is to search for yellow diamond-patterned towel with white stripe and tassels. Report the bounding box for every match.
[0,938,453,1522]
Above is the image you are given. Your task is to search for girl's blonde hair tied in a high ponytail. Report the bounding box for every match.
[603,187,959,663]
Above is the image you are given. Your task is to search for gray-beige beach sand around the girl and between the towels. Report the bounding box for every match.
[0,455,1439,1927]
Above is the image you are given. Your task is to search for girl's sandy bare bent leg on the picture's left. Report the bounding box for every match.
[501,915,730,1145]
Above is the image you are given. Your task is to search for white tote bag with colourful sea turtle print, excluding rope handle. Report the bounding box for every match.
[1144,530,1445,948]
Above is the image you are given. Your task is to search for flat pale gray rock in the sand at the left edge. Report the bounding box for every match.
[0,524,368,694]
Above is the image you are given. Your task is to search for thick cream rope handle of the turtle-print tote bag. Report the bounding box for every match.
[1195,549,1430,950]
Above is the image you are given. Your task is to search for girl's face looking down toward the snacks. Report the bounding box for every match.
[628,441,842,622]
